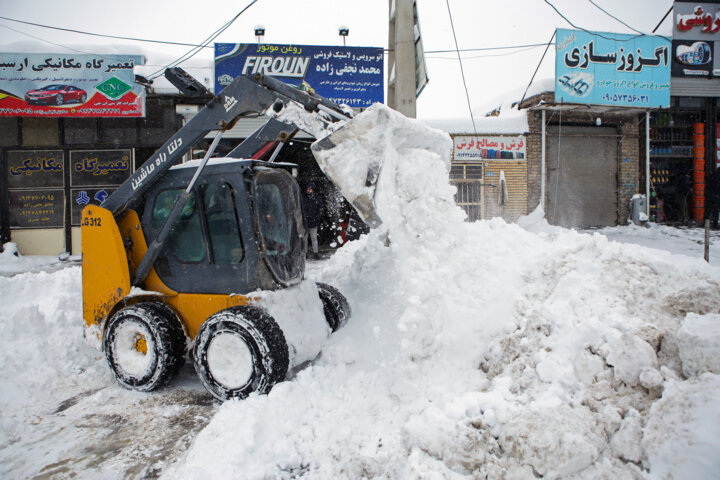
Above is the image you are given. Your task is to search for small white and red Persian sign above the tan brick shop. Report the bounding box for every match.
[453,135,526,161]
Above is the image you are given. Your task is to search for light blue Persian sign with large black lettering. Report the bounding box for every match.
[555,28,671,108]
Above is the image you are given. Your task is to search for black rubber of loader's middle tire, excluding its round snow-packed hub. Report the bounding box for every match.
[192,306,289,401]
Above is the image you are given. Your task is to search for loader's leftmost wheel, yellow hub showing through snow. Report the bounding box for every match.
[103,302,187,392]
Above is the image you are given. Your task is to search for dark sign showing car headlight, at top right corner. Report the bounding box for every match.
[672,2,720,78]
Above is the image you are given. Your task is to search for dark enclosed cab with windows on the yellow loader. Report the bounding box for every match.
[142,159,306,294]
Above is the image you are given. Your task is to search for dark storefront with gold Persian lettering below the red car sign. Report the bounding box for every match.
[0,94,184,255]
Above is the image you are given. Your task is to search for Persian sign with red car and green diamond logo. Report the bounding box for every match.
[0,53,145,117]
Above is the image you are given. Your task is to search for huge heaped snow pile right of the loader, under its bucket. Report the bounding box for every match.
[165,105,720,479]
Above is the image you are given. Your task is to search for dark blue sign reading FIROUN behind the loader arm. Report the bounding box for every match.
[215,43,384,108]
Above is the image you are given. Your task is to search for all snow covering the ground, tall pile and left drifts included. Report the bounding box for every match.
[0,107,720,479]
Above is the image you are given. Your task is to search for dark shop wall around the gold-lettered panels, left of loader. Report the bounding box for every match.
[0,95,186,255]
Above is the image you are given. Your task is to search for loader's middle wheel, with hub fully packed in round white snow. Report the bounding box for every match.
[193,306,289,401]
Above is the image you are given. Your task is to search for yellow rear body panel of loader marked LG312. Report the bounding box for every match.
[81,205,130,331]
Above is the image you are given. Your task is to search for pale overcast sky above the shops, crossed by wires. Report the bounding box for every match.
[0,0,672,118]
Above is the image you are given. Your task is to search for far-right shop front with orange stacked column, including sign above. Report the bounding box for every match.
[648,1,720,225]
